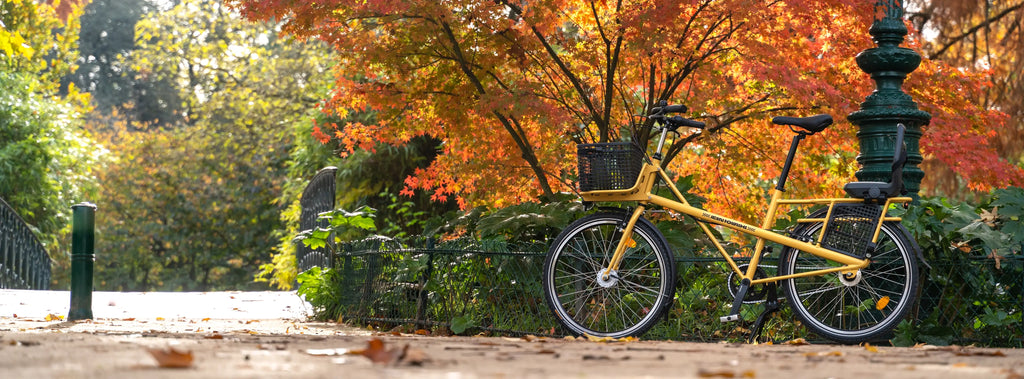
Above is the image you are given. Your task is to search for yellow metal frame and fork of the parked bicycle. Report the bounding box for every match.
[581,130,912,285]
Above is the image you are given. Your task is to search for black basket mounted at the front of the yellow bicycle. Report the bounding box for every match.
[577,142,643,193]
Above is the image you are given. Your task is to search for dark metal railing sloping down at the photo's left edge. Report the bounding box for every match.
[0,199,50,290]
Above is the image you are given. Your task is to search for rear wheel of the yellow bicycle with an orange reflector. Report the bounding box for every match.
[779,216,920,343]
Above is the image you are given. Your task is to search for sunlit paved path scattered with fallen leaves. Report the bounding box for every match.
[0,290,1024,379]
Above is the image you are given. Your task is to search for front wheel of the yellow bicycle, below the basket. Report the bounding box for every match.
[543,212,676,338]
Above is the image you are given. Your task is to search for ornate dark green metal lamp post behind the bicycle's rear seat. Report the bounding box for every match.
[847,0,932,200]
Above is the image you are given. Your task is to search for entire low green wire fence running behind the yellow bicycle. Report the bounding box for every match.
[334,238,1024,346]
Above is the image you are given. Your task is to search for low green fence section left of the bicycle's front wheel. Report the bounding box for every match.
[335,239,557,334]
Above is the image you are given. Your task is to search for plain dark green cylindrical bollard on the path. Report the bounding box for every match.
[68,203,96,321]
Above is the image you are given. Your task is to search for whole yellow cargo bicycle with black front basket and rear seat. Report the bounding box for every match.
[543,101,921,343]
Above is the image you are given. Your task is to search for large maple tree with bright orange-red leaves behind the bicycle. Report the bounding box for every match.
[229,0,1021,222]
